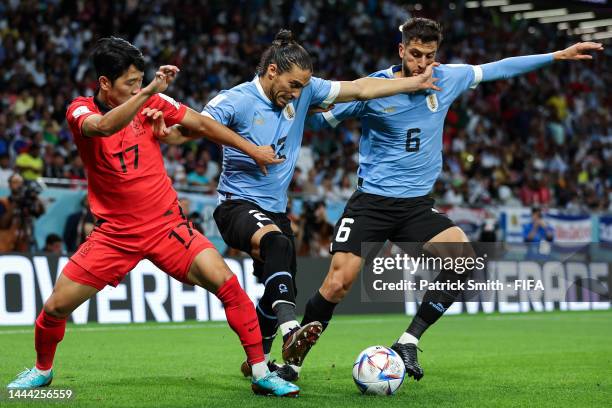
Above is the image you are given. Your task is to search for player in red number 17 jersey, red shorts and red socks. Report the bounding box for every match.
[8,37,299,396]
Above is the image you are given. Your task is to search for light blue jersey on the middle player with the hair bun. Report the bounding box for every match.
[202,76,340,213]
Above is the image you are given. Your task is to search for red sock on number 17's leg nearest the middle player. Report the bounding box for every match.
[215,275,264,365]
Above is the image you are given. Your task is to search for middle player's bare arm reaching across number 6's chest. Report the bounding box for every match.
[335,63,440,102]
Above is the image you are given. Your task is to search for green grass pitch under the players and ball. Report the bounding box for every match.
[0,311,612,408]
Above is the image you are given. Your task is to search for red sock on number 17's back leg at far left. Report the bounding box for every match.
[34,309,66,370]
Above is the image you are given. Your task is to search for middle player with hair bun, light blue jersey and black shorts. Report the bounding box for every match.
[163,30,438,378]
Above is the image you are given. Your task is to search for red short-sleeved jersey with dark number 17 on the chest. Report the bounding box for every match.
[66,94,187,227]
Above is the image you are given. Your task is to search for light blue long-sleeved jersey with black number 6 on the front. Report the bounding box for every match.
[308,54,552,198]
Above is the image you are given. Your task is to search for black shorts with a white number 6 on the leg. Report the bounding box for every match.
[330,191,455,256]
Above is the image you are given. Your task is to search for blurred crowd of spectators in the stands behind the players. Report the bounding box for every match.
[0,0,612,252]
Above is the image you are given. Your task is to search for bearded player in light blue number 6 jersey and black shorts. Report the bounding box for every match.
[302,18,603,380]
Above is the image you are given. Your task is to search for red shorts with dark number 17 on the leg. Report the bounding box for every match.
[62,203,214,290]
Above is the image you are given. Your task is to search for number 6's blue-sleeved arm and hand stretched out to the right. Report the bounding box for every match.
[474,42,603,83]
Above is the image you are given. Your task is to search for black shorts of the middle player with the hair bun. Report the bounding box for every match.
[213,200,297,282]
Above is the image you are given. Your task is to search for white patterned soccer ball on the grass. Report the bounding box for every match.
[353,346,406,395]
